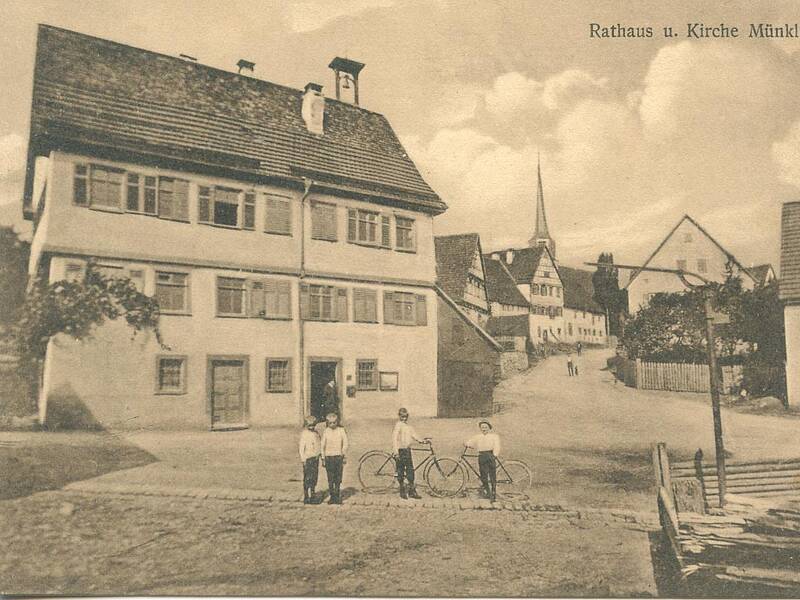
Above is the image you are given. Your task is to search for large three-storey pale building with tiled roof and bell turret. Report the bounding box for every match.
[24,25,446,429]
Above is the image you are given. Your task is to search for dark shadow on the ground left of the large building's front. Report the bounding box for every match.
[0,432,156,500]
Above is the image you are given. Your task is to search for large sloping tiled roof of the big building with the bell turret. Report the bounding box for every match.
[31,25,446,213]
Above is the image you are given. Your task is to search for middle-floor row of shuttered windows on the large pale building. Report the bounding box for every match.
[66,263,427,326]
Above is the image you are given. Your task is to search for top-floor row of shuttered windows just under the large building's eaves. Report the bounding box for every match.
[73,163,417,252]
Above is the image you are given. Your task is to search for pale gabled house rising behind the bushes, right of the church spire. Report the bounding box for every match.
[625,215,774,313]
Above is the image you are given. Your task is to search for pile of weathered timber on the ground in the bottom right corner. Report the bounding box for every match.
[677,494,800,596]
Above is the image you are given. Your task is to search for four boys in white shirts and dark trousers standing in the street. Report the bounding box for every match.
[300,408,500,504]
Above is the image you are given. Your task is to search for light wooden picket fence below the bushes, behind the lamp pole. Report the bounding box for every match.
[635,360,742,393]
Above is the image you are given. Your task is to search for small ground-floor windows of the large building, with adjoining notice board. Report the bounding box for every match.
[156,355,398,395]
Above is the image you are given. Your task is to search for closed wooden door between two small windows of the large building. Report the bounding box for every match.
[209,359,247,429]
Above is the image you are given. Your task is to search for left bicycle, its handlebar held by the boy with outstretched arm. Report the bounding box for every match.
[358,438,464,498]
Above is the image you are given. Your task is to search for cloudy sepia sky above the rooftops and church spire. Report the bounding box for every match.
[0,0,800,269]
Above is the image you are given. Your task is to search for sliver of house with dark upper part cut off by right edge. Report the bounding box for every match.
[778,202,800,407]
